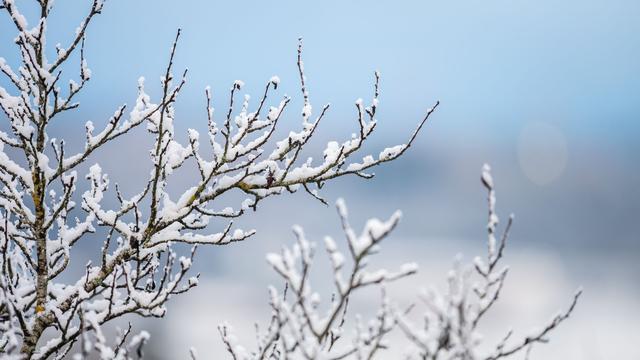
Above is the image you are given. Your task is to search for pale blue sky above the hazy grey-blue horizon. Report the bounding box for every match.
[5,0,640,144]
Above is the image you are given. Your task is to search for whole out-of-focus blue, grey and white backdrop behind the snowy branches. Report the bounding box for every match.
[0,0,640,360]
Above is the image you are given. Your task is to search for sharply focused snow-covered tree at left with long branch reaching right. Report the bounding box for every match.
[0,0,438,359]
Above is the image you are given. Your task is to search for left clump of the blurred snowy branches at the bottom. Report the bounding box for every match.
[220,200,417,359]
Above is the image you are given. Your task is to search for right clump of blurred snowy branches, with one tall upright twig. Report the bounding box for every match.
[395,165,582,360]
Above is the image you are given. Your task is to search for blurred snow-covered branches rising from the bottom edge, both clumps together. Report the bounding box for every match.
[219,165,582,360]
